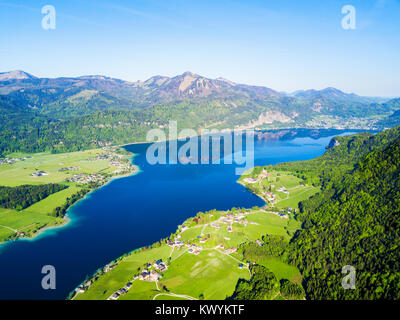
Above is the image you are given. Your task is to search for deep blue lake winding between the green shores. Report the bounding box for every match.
[0,130,354,299]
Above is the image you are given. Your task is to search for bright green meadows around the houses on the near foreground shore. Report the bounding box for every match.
[75,210,301,300]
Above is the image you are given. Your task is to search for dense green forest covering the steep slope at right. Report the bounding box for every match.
[268,127,400,299]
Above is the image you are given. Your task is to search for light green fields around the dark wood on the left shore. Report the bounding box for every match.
[0,149,134,243]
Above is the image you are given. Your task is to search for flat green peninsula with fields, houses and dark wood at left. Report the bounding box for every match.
[0,146,136,243]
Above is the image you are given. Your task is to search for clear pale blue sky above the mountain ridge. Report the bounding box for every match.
[0,0,400,96]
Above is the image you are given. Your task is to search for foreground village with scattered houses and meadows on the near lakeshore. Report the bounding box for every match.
[70,188,304,300]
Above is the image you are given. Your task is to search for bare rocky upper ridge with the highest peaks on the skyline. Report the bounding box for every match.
[0,71,281,104]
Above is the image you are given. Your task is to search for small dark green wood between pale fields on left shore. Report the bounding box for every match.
[0,183,68,210]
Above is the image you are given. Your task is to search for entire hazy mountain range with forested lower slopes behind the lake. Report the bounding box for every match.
[0,70,400,153]
